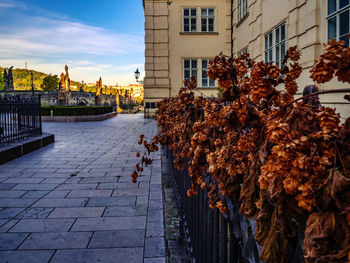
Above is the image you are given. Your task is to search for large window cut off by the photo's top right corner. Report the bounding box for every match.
[327,0,350,46]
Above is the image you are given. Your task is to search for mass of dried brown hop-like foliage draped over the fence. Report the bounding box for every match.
[131,41,350,263]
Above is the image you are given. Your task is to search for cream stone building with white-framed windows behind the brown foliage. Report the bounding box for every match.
[143,0,350,117]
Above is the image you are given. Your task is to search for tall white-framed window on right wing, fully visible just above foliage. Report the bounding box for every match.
[265,23,286,67]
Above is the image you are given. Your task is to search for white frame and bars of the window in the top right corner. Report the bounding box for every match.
[326,0,350,46]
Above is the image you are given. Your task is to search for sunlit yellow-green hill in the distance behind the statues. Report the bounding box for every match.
[0,66,81,90]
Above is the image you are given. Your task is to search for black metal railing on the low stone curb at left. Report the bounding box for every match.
[0,95,42,145]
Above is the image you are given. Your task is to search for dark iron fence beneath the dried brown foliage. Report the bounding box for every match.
[167,151,304,263]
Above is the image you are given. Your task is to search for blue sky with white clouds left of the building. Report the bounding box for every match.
[0,0,144,85]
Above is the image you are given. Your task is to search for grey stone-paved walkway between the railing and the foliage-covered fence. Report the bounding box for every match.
[0,114,165,263]
